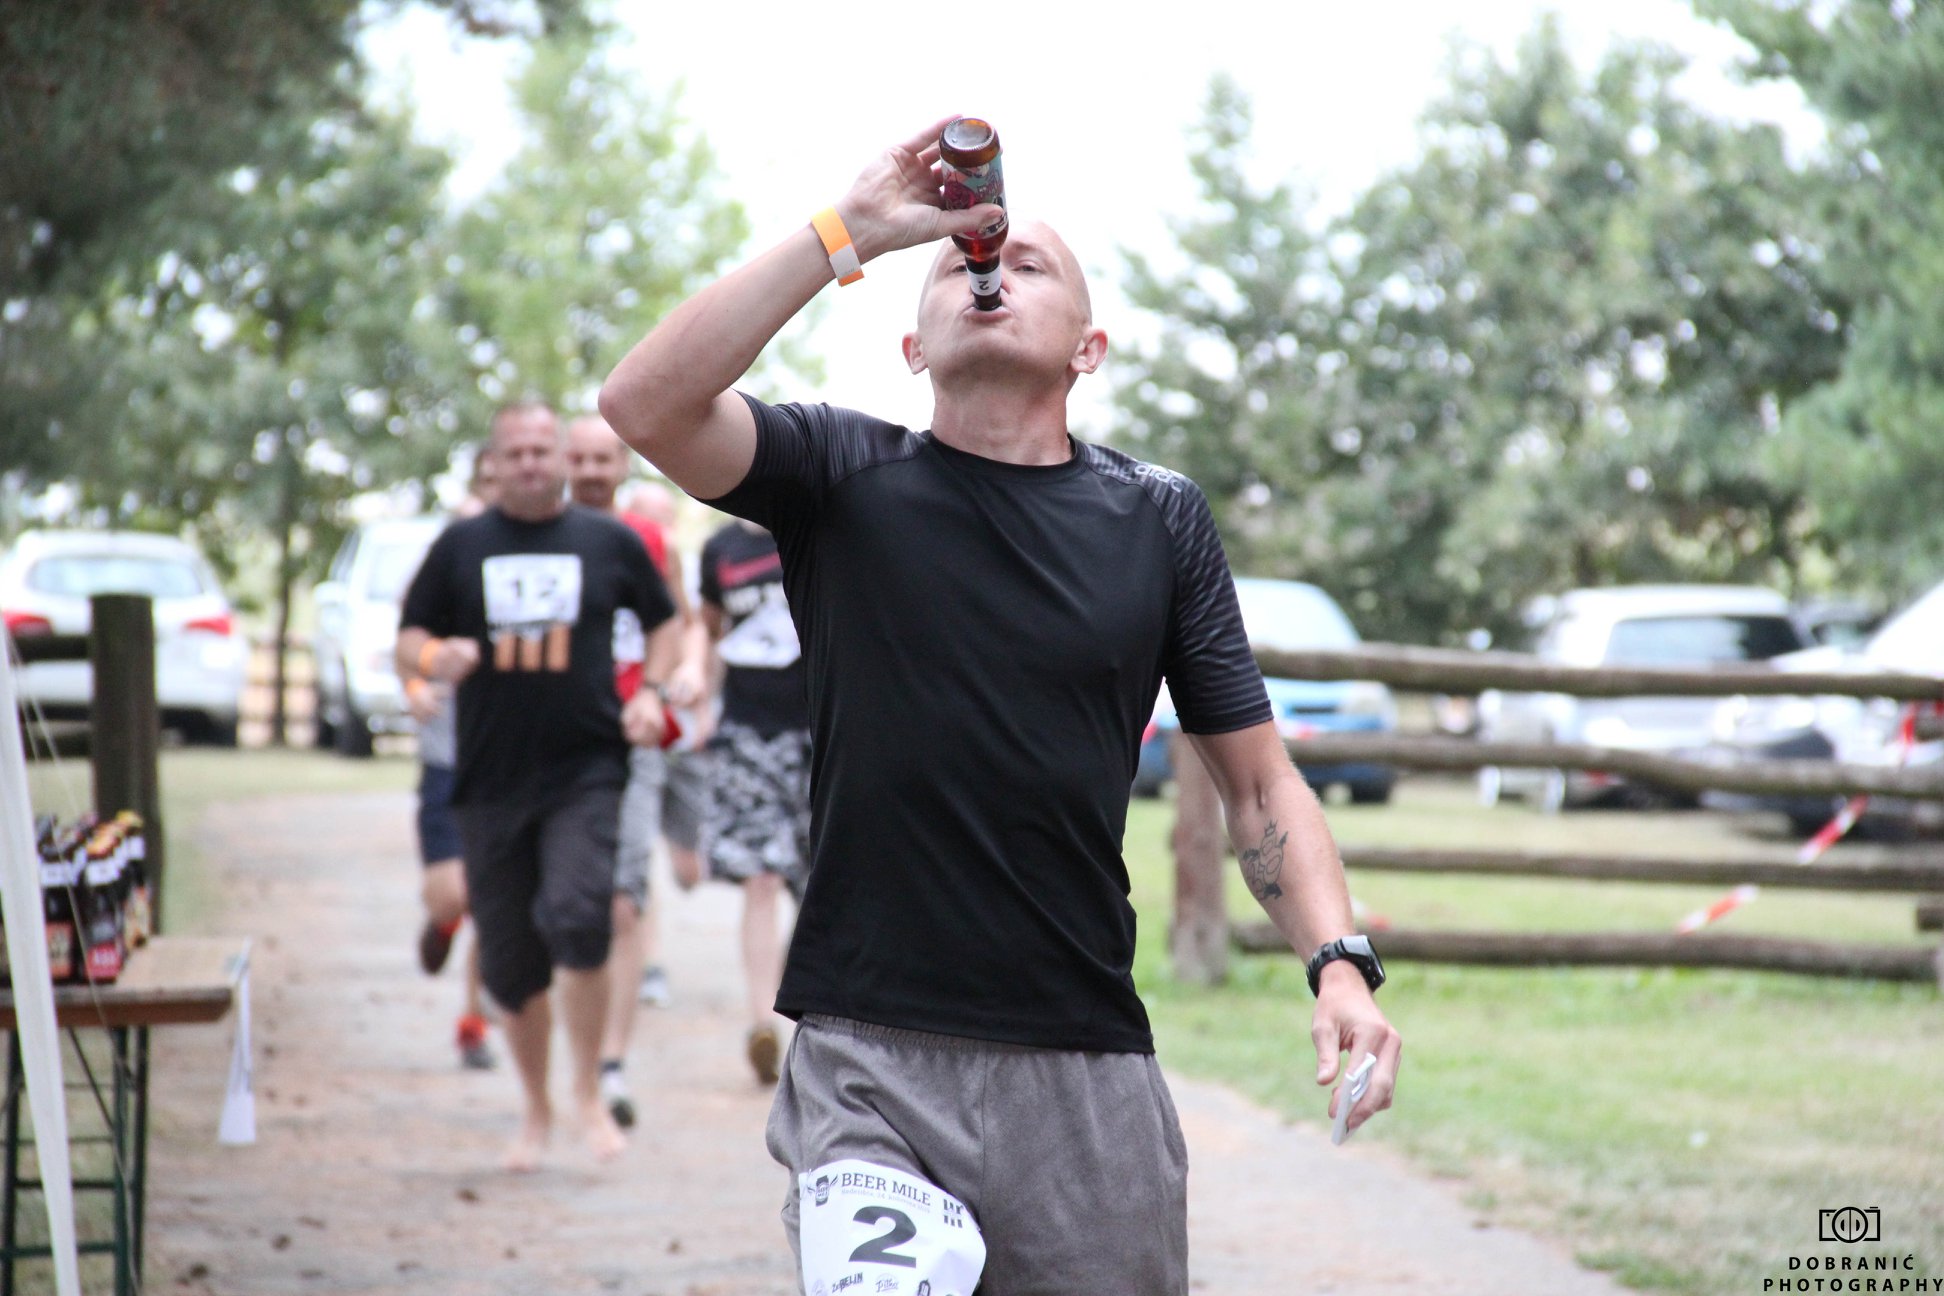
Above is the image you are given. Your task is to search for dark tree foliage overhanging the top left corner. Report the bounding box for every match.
[0,0,579,486]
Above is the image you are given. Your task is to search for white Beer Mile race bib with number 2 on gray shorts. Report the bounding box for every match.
[797,1160,986,1296]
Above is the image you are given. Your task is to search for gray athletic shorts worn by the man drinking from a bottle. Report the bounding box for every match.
[768,1016,1188,1296]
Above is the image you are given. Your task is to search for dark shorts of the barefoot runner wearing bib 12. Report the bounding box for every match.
[453,787,620,1012]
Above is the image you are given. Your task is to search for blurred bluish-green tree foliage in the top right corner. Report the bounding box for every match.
[1697,0,1944,595]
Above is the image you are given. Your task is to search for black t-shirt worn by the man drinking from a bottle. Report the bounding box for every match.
[713,398,1271,1053]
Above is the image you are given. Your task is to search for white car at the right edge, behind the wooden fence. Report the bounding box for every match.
[1707,583,1944,836]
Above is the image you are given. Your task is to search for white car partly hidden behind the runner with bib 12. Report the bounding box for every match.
[313,517,445,756]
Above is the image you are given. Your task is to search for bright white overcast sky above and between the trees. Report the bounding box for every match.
[367,0,1808,437]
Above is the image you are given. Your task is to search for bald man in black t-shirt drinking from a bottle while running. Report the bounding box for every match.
[601,122,1400,1296]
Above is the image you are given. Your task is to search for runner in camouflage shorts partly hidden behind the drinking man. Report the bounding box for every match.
[700,521,811,1084]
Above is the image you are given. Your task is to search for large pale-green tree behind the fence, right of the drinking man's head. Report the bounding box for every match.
[1122,33,1845,641]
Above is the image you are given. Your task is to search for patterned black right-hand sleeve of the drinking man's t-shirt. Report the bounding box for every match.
[1085,445,1275,734]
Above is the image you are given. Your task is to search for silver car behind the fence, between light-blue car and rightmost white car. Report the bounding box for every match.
[1477,585,1802,812]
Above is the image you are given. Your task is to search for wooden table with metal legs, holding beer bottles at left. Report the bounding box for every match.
[0,937,249,1296]
